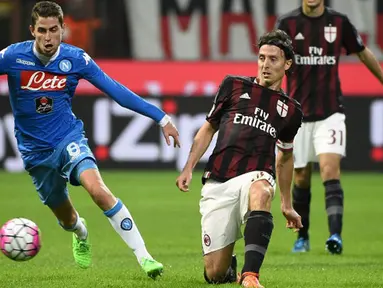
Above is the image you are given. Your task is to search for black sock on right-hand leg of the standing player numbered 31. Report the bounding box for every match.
[323,180,343,235]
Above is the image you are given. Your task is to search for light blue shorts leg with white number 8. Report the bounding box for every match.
[60,136,101,186]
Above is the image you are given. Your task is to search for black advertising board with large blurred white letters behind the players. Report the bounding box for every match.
[0,93,383,171]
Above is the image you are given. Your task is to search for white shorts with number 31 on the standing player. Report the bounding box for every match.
[294,113,346,168]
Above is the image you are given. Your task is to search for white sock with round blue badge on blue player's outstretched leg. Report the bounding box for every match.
[104,199,153,263]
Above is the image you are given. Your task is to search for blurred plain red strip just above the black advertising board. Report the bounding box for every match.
[0,59,383,96]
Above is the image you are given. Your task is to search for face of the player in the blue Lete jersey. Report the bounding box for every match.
[29,17,65,57]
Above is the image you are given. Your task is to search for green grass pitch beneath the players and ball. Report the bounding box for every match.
[0,171,383,288]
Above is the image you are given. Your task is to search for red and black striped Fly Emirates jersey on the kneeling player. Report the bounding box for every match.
[203,76,302,182]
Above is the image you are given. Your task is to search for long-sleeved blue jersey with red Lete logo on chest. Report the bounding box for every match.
[0,41,165,154]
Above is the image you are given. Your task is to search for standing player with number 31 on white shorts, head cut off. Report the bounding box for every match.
[276,0,383,254]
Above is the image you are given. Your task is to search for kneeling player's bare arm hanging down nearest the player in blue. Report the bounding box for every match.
[176,121,217,192]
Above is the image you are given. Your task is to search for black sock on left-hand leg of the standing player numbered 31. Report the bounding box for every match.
[293,185,311,239]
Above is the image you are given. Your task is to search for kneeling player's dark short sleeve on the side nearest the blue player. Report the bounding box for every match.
[206,76,233,127]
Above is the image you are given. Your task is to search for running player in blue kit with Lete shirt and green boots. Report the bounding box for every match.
[0,1,180,278]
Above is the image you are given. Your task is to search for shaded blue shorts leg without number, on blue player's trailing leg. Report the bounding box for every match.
[29,166,68,210]
